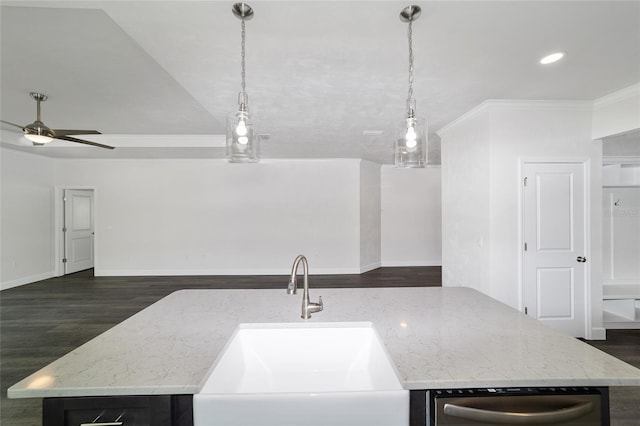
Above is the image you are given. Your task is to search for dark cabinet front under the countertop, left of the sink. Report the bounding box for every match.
[42,395,193,426]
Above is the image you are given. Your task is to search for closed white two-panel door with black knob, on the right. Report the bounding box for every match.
[523,163,588,337]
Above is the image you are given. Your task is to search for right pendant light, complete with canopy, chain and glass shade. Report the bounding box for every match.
[395,5,427,168]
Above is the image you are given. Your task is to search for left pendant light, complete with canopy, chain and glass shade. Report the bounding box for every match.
[227,3,260,163]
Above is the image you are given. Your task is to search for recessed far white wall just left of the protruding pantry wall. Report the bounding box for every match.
[381,166,442,266]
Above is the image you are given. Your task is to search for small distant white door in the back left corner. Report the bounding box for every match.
[63,189,93,274]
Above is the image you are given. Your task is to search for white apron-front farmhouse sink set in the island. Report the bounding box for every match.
[193,322,409,426]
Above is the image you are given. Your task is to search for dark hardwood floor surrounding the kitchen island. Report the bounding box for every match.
[0,267,640,426]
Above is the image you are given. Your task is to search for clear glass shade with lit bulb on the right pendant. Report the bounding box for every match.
[395,114,427,168]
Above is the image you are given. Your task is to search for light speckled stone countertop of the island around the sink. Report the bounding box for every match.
[8,287,640,398]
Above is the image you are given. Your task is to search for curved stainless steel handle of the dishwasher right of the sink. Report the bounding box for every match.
[444,401,593,425]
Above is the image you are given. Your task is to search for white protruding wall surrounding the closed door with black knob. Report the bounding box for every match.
[440,101,602,336]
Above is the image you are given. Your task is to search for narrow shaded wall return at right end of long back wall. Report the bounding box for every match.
[360,161,382,272]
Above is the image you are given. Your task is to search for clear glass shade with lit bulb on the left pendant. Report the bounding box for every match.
[227,104,260,163]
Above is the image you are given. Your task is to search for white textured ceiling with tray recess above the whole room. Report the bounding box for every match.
[0,0,640,163]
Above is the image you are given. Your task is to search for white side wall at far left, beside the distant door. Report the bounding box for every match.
[0,149,55,289]
